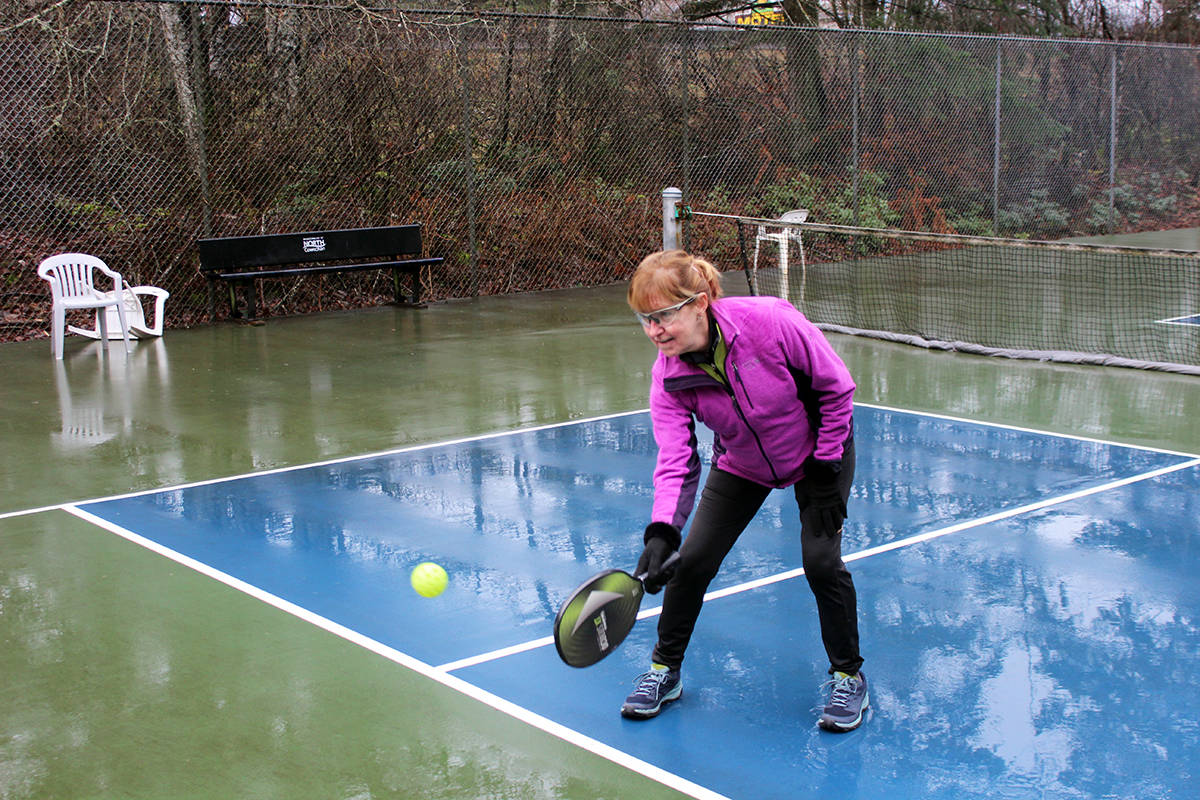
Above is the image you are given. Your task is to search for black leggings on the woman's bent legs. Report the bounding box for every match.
[654,439,863,674]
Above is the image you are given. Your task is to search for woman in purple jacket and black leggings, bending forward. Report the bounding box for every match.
[620,251,869,732]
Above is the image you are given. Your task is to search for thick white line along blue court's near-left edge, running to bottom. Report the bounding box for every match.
[60,505,728,800]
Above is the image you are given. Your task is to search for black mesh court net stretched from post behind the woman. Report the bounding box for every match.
[682,210,1200,374]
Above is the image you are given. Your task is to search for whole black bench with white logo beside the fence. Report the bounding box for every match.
[196,224,442,320]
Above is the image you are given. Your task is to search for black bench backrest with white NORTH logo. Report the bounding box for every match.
[196,224,421,271]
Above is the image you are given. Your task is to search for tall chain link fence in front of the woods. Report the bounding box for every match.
[0,1,1200,341]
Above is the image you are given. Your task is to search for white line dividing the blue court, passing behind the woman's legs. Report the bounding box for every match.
[438,458,1200,672]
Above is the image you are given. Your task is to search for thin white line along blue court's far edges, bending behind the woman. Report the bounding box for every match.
[0,403,1200,519]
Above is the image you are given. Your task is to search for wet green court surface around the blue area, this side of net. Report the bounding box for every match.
[0,277,1200,800]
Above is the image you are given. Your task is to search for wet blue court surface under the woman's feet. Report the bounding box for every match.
[70,405,1200,798]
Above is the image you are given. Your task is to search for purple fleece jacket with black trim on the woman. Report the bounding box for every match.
[650,297,854,529]
